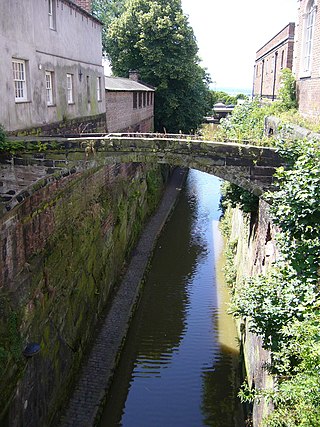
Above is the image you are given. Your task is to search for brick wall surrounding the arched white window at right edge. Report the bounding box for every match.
[293,0,320,117]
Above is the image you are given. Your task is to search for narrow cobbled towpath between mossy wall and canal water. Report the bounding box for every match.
[59,168,187,427]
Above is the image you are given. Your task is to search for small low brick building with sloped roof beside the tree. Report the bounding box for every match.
[105,72,155,133]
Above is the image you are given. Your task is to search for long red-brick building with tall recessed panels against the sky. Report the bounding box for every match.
[253,22,295,100]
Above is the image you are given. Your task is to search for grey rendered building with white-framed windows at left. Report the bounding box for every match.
[0,0,105,134]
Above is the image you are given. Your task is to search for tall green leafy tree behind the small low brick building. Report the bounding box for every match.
[106,0,209,133]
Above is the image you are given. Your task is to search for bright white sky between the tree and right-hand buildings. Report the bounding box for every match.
[181,0,298,89]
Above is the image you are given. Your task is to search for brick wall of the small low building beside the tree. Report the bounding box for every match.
[106,91,154,132]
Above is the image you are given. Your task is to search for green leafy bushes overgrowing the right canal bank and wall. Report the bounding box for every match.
[215,83,320,427]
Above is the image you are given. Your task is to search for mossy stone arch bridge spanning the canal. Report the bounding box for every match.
[0,134,283,211]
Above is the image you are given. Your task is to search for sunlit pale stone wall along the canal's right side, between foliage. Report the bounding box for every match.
[230,200,277,427]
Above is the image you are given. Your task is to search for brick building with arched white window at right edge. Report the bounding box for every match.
[293,0,320,117]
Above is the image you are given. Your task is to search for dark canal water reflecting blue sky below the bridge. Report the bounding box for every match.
[100,170,243,427]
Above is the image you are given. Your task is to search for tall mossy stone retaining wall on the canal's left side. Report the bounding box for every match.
[0,164,168,427]
